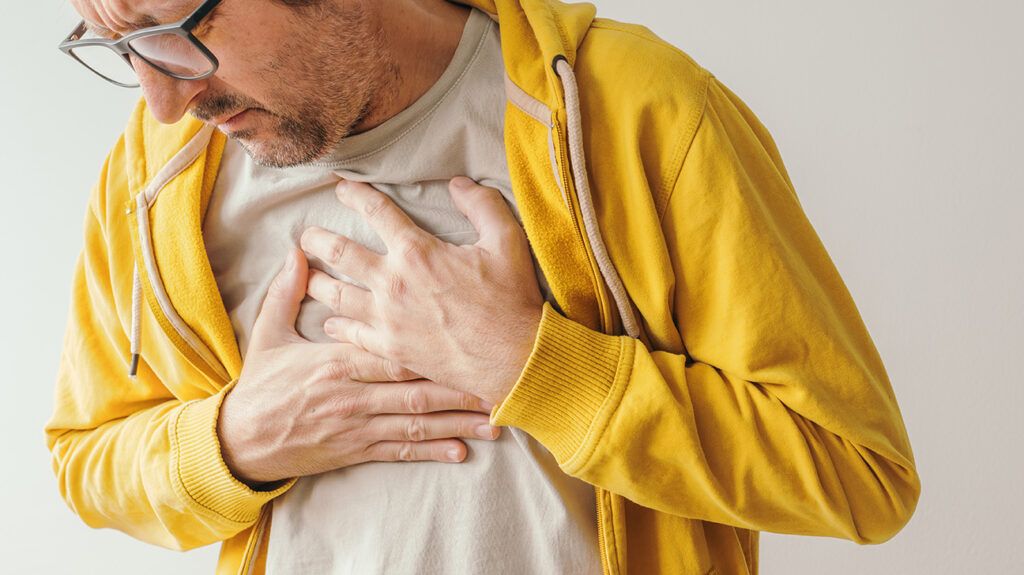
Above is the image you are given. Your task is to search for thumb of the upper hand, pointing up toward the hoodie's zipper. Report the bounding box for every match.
[449,176,528,254]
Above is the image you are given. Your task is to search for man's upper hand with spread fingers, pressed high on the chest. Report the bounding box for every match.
[301,178,544,404]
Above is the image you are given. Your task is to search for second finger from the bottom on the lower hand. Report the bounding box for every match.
[366,411,501,441]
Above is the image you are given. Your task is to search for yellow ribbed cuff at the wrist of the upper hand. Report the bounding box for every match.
[490,302,634,466]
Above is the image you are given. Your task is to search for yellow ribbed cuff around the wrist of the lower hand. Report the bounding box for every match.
[171,380,296,524]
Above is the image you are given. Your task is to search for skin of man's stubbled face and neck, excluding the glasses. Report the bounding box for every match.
[72,0,468,167]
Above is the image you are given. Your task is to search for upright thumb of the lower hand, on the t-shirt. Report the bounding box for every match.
[252,248,309,346]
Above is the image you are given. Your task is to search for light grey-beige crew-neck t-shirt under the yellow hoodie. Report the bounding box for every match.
[204,9,601,575]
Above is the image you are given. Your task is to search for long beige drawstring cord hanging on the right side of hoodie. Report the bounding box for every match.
[554,55,640,339]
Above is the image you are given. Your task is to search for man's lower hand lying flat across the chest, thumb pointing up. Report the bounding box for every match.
[217,250,500,486]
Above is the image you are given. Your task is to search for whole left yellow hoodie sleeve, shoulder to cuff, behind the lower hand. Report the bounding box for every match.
[45,136,294,549]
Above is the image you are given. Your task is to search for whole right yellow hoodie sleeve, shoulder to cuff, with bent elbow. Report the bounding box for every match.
[492,79,921,543]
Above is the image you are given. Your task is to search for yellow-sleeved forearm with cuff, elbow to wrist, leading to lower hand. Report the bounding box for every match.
[47,382,290,549]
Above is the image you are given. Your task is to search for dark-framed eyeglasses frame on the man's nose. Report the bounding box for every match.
[57,0,221,88]
